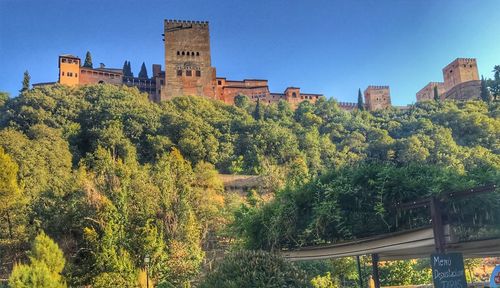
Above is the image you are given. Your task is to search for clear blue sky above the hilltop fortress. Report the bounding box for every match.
[0,0,500,105]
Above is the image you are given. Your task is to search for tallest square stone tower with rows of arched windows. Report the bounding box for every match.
[161,20,215,100]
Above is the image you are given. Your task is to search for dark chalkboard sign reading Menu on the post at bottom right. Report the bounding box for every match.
[431,253,467,288]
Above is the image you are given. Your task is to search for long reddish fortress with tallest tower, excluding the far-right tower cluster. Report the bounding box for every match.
[34,20,398,111]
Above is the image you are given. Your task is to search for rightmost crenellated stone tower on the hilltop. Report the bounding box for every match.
[443,58,479,91]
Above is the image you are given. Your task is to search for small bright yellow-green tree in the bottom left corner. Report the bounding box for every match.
[9,232,66,288]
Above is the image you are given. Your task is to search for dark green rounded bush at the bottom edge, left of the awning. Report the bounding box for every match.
[200,251,308,288]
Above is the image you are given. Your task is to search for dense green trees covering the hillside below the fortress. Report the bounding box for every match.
[0,85,500,287]
